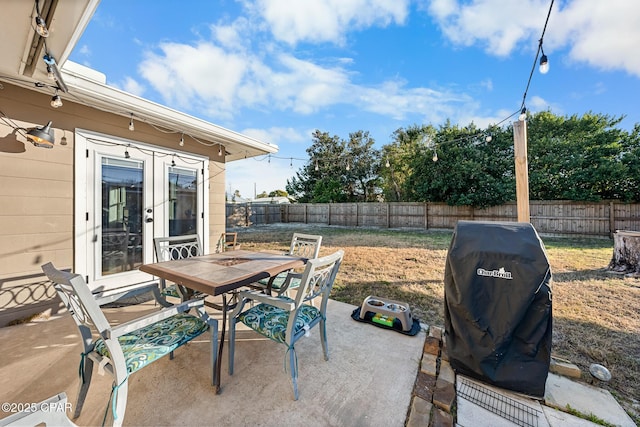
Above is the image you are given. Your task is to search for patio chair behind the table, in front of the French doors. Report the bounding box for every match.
[153,234,203,304]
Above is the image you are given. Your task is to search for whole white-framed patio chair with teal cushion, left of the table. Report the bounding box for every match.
[42,263,218,426]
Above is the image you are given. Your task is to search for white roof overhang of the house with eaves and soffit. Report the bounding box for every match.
[0,0,278,161]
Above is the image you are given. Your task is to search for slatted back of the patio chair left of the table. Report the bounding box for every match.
[42,262,111,353]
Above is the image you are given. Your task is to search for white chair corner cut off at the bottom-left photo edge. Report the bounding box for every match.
[0,392,76,427]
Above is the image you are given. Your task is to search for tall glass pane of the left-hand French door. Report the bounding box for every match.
[101,157,144,276]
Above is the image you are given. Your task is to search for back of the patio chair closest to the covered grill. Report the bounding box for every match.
[295,250,344,314]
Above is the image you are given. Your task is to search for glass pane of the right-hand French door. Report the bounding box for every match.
[169,166,198,236]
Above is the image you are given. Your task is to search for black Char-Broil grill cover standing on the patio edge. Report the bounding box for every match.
[444,221,552,397]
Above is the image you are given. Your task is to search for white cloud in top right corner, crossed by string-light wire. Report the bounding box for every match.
[427,0,640,76]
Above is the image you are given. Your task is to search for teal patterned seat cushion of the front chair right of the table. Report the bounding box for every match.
[238,297,322,343]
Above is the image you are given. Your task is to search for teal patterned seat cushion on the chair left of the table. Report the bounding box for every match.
[94,313,208,374]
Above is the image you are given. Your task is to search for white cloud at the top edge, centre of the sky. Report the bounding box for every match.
[255,0,409,45]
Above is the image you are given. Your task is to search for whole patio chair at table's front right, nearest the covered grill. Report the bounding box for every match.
[229,250,344,400]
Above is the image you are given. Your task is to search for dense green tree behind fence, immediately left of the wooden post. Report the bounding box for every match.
[382,121,515,207]
